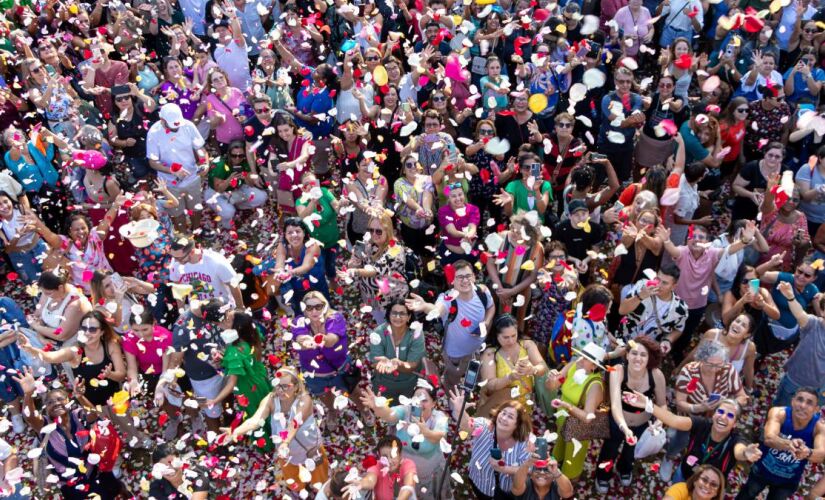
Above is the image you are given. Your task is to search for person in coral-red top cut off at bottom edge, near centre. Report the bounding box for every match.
[349,435,416,500]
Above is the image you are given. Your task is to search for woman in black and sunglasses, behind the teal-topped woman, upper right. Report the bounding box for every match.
[635,73,689,179]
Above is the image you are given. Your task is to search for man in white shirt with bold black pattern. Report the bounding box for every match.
[619,265,688,354]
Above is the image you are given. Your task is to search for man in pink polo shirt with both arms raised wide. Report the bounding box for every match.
[656,221,756,363]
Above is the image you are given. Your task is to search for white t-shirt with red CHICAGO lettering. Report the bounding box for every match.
[169,250,236,306]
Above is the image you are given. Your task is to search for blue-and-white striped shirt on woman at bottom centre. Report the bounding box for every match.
[470,418,530,496]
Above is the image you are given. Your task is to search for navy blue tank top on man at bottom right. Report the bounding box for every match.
[753,406,820,487]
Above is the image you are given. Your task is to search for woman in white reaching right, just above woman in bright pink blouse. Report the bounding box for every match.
[90,271,155,335]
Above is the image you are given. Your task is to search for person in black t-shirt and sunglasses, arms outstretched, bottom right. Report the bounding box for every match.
[622,391,762,483]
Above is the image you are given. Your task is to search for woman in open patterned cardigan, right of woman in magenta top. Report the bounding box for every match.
[486,214,544,322]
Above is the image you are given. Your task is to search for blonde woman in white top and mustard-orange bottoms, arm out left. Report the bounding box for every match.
[223,366,329,494]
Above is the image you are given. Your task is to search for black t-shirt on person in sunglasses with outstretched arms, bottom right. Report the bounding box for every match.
[682,417,744,478]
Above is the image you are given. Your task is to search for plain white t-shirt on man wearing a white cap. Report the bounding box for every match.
[146,120,206,188]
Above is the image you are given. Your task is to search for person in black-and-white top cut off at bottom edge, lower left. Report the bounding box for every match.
[149,444,209,500]
